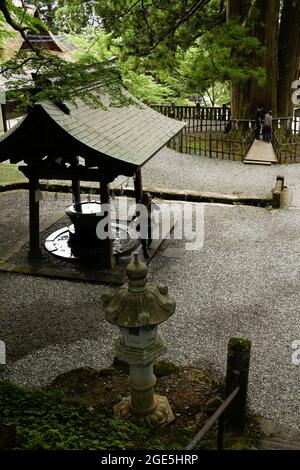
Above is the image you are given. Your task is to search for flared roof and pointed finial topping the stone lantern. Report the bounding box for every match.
[102,254,176,328]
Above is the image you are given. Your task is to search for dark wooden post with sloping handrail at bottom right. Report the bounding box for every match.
[185,338,251,450]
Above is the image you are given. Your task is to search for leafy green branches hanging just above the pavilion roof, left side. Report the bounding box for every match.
[2,51,132,110]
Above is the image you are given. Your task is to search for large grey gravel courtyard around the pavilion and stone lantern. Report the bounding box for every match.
[0,187,300,428]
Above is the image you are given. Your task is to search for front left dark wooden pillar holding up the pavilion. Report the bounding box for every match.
[29,177,41,258]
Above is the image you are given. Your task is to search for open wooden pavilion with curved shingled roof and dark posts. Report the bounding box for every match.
[0,91,185,268]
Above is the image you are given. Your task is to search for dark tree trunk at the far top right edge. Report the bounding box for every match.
[278,0,300,117]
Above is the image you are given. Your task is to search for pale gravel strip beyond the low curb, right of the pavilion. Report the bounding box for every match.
[142,147,300,195]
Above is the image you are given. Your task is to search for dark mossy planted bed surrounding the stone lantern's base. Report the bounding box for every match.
[0,361,260,450]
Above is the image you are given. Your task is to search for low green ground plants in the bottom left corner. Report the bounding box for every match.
[0,381,145,450]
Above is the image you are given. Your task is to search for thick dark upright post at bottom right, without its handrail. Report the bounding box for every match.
[225,338,251,432]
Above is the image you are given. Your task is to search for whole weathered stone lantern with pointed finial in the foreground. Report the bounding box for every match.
[102,254,176,427]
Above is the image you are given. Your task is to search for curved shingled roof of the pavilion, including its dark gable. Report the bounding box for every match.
[0,92,185,175]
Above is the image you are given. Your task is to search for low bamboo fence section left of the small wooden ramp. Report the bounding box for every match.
[169,128,255,161]
